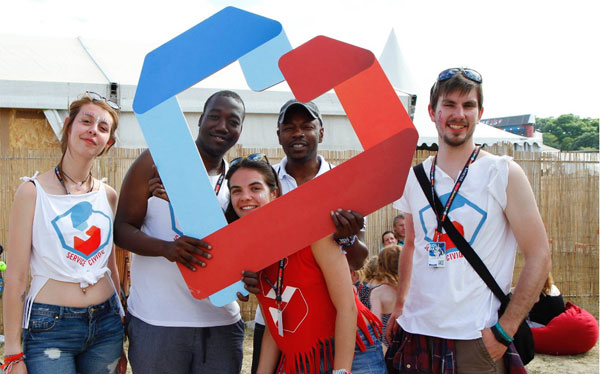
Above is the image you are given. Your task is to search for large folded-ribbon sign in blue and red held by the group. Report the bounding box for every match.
[133,7,418,305]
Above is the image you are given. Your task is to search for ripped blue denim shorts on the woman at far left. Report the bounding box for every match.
[23,294,123,374]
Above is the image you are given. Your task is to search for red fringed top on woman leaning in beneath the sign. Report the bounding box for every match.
[256,246,382,374]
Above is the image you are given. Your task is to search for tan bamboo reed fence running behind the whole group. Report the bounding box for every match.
[0,145,599,328]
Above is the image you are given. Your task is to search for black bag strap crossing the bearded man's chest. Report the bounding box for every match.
[413,163,509,307]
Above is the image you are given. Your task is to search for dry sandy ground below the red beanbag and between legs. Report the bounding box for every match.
[0,329,599,374]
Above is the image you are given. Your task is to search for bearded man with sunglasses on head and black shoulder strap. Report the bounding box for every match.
[386,68,550,374]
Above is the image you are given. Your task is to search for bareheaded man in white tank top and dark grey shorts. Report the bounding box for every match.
[114,91,245,374]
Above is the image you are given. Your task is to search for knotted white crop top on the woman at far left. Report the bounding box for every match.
[23,174,119,328]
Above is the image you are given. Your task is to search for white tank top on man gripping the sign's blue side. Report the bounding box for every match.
[127,172,241,327]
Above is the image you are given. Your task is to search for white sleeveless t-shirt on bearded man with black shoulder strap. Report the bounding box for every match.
[394,155,517,339]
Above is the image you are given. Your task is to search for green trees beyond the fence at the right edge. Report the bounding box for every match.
[535,114,598,151]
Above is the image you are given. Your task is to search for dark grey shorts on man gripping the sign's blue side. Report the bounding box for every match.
[127,314,244,374]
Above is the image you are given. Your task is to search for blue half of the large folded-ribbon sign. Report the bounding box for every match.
[133,7,292,305]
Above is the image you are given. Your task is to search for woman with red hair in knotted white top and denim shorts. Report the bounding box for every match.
[2,92,127,374]
